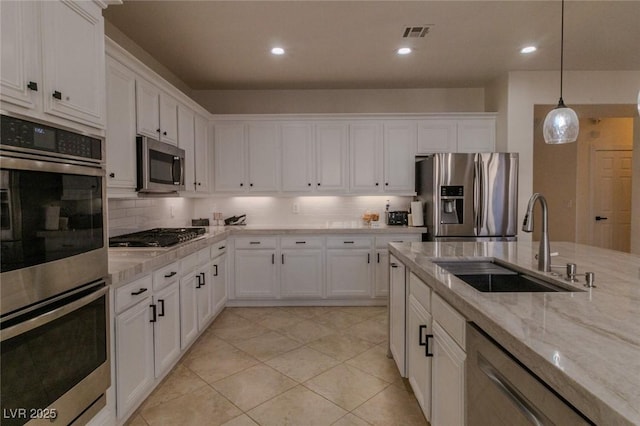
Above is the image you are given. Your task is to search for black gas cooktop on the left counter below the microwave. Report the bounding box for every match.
[109,228,206,247]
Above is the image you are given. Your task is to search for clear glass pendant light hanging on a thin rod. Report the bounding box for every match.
[542,0,580,144]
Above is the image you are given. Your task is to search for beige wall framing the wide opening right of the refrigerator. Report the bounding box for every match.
[500,71,640,250]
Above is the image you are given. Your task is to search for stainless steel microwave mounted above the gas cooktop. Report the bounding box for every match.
[136,136,185,194]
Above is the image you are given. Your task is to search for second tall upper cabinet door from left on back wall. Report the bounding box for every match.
[247,123,280,192]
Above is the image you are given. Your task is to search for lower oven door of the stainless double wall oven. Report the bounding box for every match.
[0,281,111,425]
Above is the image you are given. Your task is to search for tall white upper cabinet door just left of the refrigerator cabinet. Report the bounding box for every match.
[384,122,416,193]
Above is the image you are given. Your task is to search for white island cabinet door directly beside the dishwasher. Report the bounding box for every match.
[431,321,466,426]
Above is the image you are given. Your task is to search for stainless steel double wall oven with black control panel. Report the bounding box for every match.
[0,115,111,425]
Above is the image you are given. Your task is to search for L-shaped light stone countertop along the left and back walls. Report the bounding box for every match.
[109,225,427,287]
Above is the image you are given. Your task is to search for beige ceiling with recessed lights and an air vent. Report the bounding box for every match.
[104,0,640,90]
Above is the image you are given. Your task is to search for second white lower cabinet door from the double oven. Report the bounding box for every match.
[153,281,180,377]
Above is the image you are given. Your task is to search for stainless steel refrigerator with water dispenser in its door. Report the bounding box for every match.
[416,152,518,241]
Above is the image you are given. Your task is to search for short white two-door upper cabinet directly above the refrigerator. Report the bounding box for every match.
[418,115,496,154]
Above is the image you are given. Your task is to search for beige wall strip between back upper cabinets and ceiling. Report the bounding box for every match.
[191,88,485,114]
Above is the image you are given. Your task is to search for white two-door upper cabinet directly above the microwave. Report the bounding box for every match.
[136,78,178,145]
